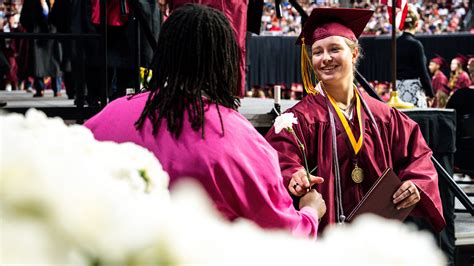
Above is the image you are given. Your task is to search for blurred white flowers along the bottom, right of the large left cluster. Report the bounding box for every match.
[167,183,446,266]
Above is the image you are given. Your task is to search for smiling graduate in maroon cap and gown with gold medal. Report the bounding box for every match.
[266,8,445,231]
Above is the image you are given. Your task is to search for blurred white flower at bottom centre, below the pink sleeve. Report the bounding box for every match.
[165,180,317,265]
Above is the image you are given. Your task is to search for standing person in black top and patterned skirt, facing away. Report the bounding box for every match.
[397,5,434,108]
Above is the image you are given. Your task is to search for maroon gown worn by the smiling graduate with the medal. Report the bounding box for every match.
[266,93,445,231]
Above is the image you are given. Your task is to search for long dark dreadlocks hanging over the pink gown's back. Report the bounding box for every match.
[135,4,241,138]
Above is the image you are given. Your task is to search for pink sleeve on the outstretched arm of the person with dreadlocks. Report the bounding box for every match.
[213,132,318,239]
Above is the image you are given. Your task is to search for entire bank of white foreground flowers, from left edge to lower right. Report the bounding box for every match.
[0,110,445,266]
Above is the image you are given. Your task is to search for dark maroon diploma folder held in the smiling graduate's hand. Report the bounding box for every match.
[347,168,416,222]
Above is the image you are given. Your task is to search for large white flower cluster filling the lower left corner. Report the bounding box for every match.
[0,110,169,265]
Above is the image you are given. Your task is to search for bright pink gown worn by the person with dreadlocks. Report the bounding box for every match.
[85,93,318,238]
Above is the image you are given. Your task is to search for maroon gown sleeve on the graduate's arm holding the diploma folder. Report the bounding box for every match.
[390,109,446,231]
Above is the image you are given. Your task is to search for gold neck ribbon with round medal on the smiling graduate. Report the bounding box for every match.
[324,85,364,183]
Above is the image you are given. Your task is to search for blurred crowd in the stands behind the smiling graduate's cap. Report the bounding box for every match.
[261,0,472,35]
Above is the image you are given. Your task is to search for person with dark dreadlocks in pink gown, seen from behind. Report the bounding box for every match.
[85,4,325,238]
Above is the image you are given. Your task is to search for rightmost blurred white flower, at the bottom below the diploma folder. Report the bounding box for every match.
[316,214,446,265]
